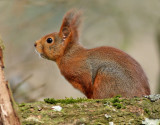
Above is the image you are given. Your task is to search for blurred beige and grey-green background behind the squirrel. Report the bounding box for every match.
[0,0,160,102]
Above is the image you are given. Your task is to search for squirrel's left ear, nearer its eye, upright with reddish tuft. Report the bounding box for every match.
[59,9,75,38]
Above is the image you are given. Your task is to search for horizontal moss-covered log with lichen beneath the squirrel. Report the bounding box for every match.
[19,97,160,125]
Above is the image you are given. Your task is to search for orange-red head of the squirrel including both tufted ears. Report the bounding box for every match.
[34,10,81,61]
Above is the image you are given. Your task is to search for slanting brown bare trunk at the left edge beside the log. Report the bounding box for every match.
[0,46,20,125]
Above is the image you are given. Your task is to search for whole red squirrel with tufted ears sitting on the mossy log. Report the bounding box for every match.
[34,10,150,99]
